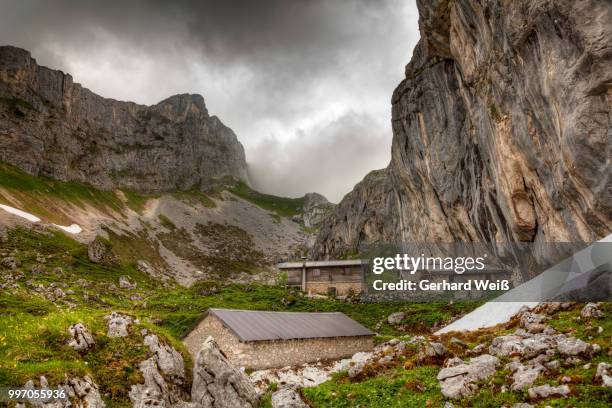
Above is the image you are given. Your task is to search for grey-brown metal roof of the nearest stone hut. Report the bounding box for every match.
[208,308,374,341]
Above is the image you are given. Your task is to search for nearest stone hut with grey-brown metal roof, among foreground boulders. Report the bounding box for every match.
[184,309,374,369]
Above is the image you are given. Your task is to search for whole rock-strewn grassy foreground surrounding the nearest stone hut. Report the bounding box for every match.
[0,226,612,408]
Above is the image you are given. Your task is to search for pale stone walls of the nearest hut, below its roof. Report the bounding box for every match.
[185,315,374,369]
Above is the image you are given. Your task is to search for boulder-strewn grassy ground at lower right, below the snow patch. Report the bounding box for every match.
[302,303,612,408]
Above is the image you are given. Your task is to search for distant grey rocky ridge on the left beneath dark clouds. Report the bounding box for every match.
[0,46,246,192]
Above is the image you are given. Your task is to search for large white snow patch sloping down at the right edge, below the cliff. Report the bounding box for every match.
[435,234,612,334]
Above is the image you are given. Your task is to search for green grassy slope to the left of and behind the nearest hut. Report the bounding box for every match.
[0,228,478,407]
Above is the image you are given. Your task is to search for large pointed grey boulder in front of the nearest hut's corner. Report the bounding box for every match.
[191,337,259,408]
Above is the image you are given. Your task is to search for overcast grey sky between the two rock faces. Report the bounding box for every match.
[0,0,418,201]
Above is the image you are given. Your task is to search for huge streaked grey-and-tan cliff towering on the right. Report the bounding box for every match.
[315,0,612,257]
